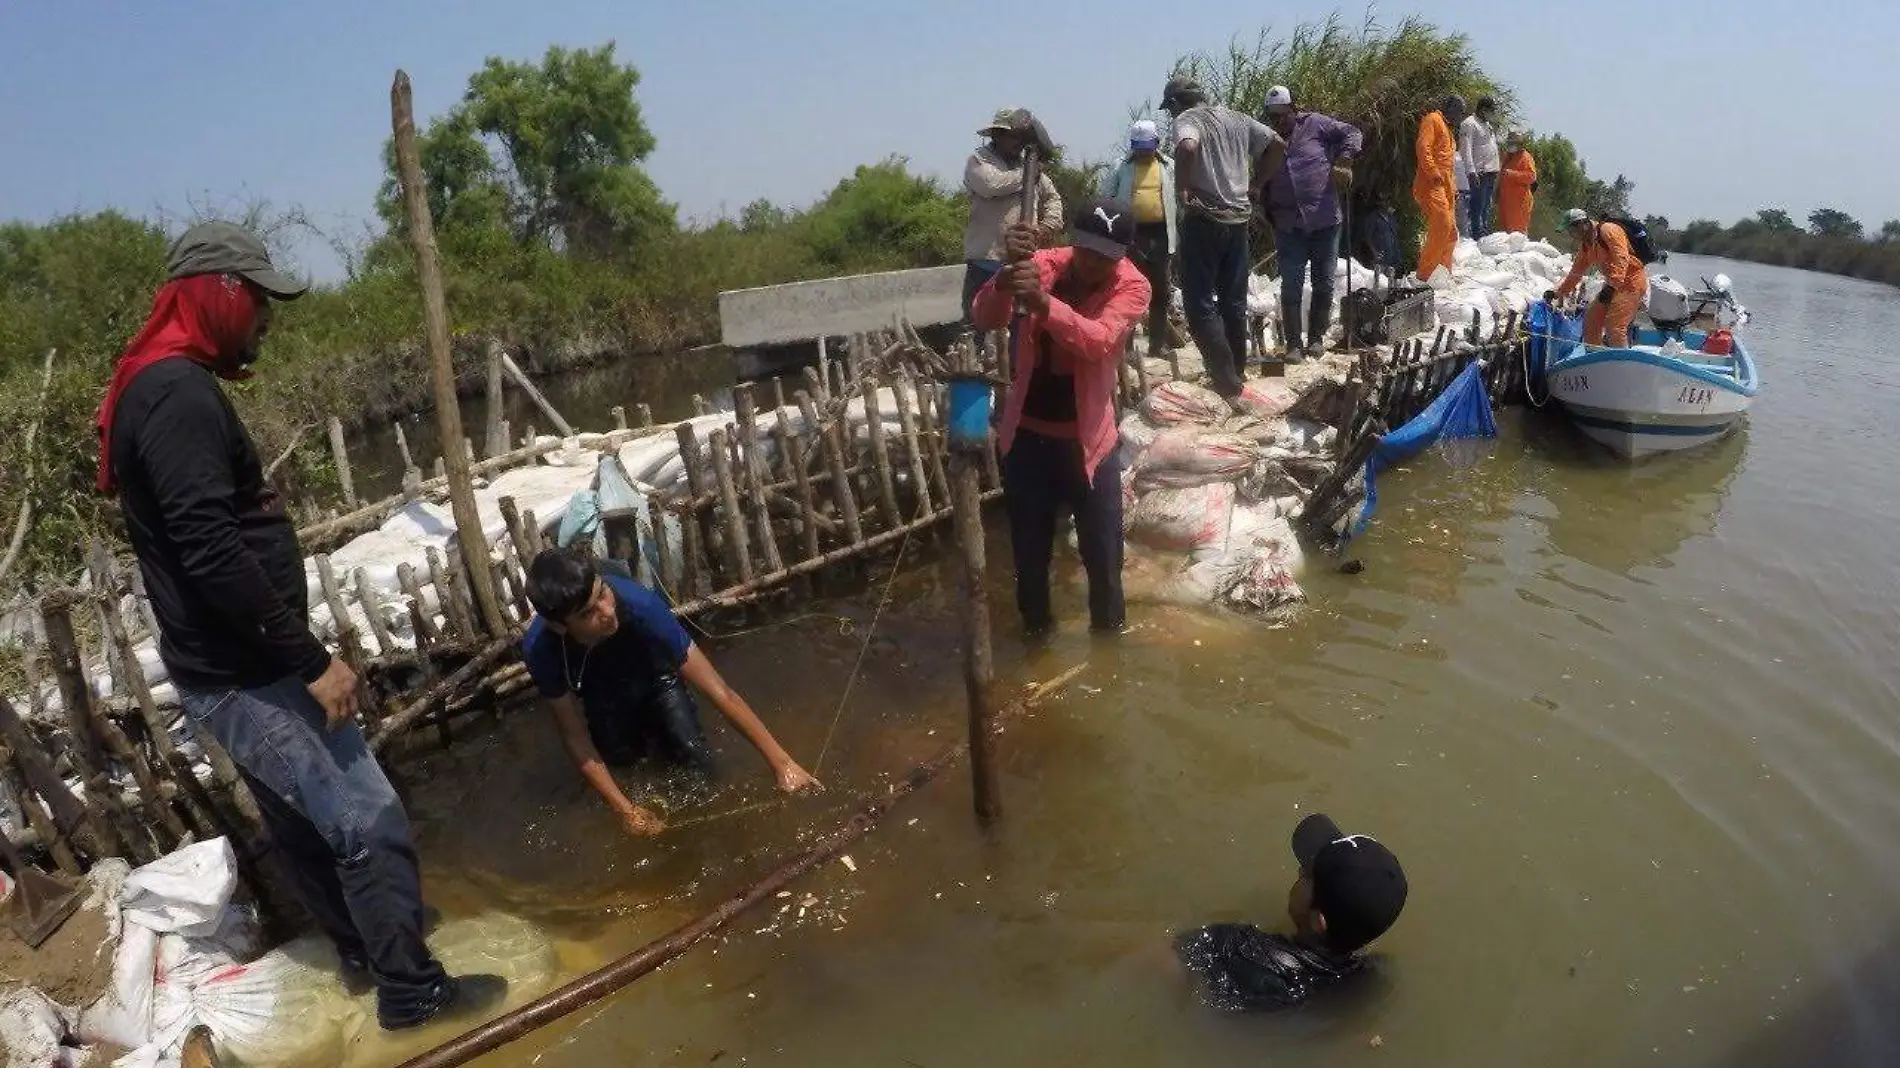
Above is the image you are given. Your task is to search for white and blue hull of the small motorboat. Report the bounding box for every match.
[1549,332,1756,460]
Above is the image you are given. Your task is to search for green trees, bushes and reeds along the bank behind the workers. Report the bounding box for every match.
[0,15,1632,577]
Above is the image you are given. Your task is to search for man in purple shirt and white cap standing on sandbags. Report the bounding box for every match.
[1265,86,1360,363]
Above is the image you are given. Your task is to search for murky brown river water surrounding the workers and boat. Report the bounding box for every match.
[342,257,1900,1068]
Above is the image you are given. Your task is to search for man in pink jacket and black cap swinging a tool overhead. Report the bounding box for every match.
[971,200,1150,633]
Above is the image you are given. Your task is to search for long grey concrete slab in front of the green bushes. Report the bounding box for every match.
[718,264,963,348]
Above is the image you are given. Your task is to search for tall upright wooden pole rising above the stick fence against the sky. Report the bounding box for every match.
[390,70,507,635]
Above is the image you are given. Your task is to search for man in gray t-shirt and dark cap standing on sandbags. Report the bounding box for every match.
[1161,76,1286,397]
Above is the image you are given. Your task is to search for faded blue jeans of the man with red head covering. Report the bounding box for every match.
[179,678,447,1020]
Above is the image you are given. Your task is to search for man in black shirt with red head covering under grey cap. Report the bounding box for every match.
[99,222,504,1030]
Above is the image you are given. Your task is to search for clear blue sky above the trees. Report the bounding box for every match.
[0,0,1900,277]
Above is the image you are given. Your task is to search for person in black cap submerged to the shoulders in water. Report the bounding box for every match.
[1174,815,1406,1011]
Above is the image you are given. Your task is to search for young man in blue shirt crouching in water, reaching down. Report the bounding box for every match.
[521,549,819,836]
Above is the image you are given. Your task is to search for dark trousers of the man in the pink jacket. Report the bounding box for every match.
[1003,429,1129,633]
